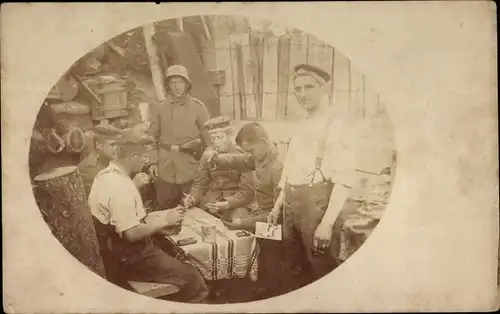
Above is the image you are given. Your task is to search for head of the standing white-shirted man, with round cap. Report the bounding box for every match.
[293,64,330,110]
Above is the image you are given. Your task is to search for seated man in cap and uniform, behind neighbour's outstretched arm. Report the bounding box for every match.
[183,116,255,220]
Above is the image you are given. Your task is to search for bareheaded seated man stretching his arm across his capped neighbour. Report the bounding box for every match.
[200,122,299,298]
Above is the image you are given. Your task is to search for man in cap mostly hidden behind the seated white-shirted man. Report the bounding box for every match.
[77,124,149,197]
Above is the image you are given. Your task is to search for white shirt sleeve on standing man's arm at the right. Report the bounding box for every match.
[323,123,356,187]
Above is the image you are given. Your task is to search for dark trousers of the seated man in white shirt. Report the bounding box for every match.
[121,246,208,303]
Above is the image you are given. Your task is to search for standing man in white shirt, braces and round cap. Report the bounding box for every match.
[268,64,355,284]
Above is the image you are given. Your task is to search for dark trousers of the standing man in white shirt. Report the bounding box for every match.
[283,181,341,286]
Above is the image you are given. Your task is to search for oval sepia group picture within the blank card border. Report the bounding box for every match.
[29,15,397,303]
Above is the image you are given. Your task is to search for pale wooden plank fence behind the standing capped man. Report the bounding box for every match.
[202,28,394,177]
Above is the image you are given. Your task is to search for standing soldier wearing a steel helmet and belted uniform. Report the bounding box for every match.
[148,65,210,208]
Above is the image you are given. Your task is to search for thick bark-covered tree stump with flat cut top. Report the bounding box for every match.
[34,166,105,277]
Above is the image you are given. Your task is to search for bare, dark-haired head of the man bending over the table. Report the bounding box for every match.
[235,122,273,160]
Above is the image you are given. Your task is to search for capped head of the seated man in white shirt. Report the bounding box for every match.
[116,128,154,172]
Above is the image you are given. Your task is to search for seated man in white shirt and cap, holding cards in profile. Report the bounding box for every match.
[88,128,208,303]
